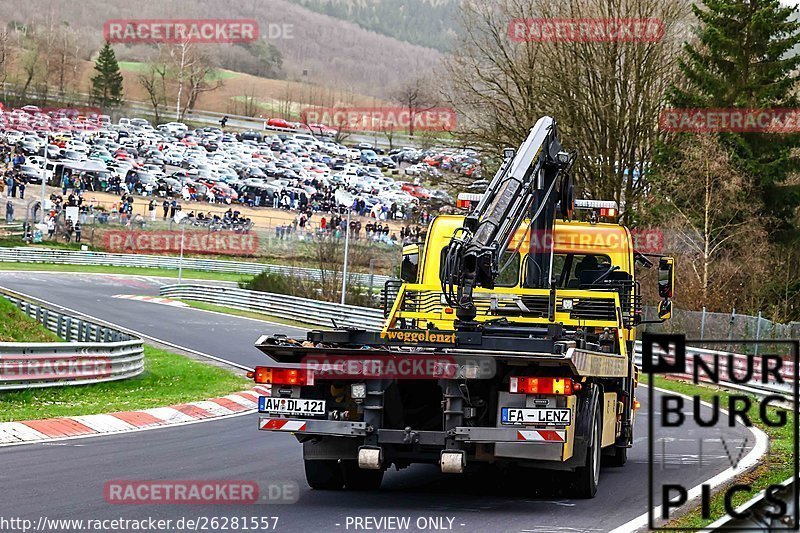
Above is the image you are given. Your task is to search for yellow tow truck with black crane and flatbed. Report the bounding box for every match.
[252,117,674,497]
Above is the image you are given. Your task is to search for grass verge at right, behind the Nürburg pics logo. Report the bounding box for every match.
[642,376,797,529]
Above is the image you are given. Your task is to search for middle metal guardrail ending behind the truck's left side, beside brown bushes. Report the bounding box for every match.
[159,283,383,330]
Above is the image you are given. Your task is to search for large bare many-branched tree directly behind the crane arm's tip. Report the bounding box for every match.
[446,0,688,220]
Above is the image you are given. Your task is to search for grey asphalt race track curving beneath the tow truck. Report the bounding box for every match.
[0,272,754,532]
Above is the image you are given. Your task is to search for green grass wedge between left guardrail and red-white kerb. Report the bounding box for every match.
[0,346,252,422]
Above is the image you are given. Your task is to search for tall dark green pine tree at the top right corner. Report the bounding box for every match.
[668,0,800,236]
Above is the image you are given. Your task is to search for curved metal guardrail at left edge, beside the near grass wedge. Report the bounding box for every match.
[0,289,144,391]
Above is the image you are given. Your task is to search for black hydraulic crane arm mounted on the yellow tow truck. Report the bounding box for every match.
[442,117,574,320]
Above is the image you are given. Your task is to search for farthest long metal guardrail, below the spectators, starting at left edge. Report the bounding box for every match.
[0,247,389,287]
